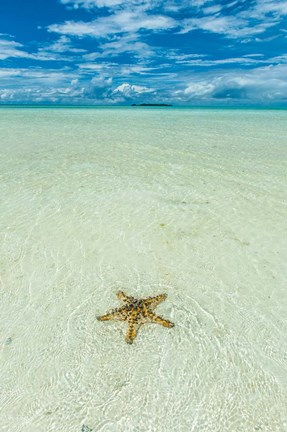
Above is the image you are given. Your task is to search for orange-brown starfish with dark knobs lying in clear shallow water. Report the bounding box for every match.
[97,291,174,344]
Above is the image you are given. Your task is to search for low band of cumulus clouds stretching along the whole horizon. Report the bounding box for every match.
[0,64,287,105]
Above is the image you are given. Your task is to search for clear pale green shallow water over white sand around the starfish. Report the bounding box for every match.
[0,108,287,432]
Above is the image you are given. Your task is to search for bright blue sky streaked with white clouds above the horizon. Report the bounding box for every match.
[0,0,287,106]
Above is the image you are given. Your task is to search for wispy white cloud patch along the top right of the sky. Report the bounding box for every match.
[45,0,287,43]
